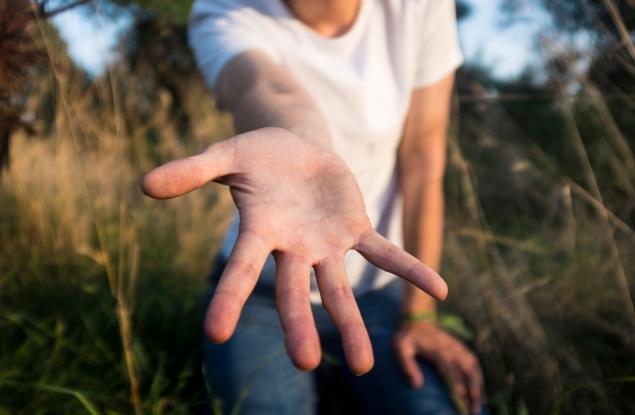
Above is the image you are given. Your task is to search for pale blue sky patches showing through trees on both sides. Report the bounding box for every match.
[53,0,548,78]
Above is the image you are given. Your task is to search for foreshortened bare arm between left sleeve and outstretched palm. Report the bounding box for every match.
[220,52,331,148]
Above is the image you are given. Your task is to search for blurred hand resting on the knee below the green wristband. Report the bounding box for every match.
[395,321,483,414]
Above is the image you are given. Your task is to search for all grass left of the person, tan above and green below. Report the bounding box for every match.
[0,19,235,413]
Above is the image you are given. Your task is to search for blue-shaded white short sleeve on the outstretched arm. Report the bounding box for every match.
[188,0,280,92]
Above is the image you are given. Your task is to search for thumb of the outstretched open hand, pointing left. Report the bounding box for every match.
[141,142,234,199]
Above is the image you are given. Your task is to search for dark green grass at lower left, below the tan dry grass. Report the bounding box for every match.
[0,256,203,413]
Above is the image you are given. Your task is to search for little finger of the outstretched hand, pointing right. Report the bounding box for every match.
[354,231,448,300]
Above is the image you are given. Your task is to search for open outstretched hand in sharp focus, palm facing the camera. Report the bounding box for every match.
[142,128,447,374]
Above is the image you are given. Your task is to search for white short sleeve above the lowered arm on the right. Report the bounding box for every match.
[414,0,463,88]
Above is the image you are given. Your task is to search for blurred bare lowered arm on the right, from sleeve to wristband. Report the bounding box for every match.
[398,74,454,313]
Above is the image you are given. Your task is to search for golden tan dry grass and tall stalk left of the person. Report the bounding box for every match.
[0,18,231,414]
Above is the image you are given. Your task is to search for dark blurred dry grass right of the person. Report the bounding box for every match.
[445,26,635,414]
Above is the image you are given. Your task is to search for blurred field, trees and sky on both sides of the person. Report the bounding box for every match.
[0,0,635,415]
